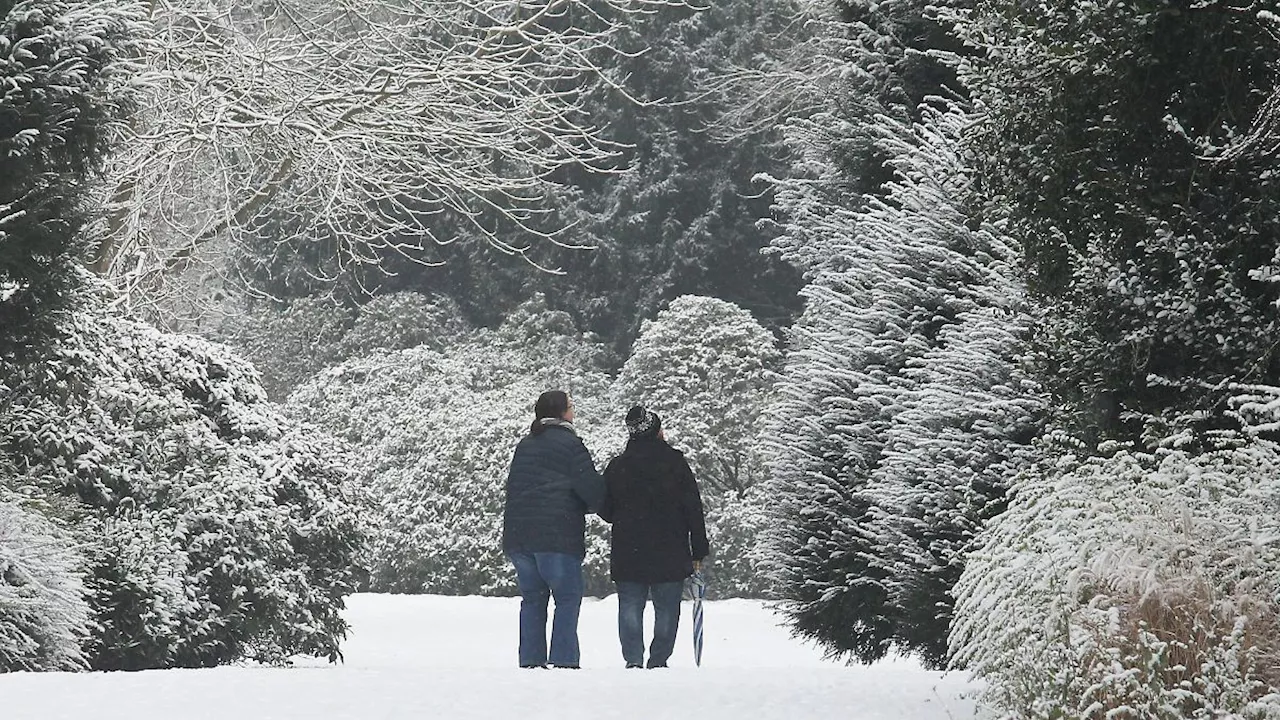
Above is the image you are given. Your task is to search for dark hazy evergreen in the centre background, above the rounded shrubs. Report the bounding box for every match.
[547,0,799,347]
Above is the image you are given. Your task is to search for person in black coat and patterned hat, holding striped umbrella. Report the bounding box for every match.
[599,406,709,667]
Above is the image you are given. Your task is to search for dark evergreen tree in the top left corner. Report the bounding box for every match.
[0,0,145,345]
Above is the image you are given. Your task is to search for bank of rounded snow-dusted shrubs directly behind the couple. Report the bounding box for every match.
[287,295,776,596]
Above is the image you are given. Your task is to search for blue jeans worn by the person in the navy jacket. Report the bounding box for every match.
[507,552,582,667]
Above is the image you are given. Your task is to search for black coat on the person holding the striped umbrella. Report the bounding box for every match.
[600,437,709,584]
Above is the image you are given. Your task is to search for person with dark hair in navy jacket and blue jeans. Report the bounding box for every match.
[502,391,604,667]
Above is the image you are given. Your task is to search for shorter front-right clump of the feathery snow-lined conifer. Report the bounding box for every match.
[877,301,1044,667]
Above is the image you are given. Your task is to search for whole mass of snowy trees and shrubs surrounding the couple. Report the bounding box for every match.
[0,0,1280,719]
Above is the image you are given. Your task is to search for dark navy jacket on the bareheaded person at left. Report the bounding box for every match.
[502,425,604,557]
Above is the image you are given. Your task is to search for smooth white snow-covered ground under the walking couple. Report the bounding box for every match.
[0,594,974,720]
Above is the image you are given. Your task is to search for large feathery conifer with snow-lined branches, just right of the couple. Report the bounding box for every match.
[768,101,1039,662]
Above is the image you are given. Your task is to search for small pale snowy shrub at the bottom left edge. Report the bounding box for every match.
[0,500,90,673]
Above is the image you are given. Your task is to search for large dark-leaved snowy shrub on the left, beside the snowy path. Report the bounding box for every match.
[0,310,364,669]
